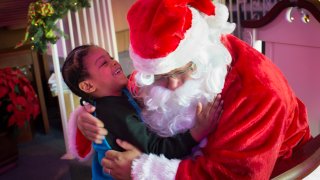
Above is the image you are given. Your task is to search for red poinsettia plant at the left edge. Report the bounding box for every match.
[0,68,40,131]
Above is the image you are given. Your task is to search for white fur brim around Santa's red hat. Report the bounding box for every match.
[129,7,209,74]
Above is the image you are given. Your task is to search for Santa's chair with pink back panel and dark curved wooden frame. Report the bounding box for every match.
[241,0,320,179]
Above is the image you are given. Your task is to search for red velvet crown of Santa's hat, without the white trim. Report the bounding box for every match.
[127,0,192,58]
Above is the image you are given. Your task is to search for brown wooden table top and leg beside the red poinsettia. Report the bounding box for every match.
[0,46,49,133]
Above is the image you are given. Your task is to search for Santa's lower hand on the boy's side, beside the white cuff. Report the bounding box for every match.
[101,139,142,179]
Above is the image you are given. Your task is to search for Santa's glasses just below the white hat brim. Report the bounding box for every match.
[154,62,196,81]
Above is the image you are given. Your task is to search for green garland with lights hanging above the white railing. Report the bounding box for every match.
[15,0,90,52]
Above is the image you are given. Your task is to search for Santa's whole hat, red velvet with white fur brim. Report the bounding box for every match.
[127,0,215,74]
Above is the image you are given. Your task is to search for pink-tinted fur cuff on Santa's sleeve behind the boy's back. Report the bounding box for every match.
[68,106,94,161]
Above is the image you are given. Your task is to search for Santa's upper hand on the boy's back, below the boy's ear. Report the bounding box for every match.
[77,104,107,144]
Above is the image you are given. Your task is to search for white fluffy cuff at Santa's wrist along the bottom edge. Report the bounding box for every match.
[131,154,180,180]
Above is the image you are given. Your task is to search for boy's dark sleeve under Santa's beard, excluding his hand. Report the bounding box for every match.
[107,111,198,158]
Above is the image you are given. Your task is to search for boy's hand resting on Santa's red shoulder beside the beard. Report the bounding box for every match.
[190,94,223,142]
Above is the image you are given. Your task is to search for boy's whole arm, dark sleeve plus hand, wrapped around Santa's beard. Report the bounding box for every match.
[97,96,222,159]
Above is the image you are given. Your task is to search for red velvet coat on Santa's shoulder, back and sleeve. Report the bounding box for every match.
[176,35,311,180]
